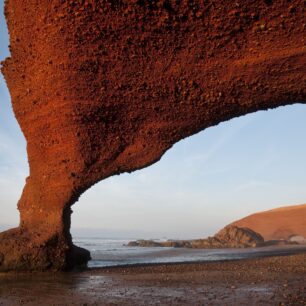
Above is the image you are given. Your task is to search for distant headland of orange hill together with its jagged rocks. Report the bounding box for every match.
[128,204,306,249]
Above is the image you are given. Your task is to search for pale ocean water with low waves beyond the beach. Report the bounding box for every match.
[74,237,306,268]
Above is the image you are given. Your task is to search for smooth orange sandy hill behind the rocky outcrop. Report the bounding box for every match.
[232,204,306,240]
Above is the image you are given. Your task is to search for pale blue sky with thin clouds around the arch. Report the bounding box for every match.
[0,0,306,239]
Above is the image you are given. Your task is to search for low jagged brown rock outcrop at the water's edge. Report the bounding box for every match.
[128,225,264,249]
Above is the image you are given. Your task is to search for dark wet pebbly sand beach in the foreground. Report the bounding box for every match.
[0,253,306,306]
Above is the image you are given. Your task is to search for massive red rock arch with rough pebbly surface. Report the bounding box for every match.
[0,0,306,270]
